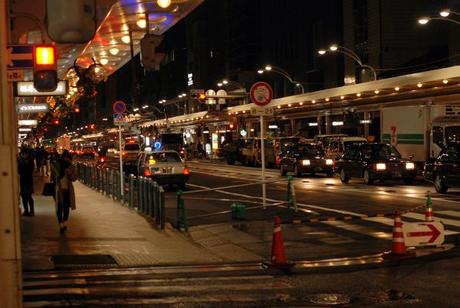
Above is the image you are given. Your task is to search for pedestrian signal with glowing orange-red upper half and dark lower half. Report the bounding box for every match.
[33,45,58,92]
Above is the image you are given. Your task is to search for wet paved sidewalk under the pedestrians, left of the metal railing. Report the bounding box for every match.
[21,177,232,270]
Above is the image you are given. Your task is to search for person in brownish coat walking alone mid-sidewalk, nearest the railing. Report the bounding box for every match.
[55,150,77,233]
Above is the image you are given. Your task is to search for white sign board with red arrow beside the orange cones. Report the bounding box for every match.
[403,221,444,247]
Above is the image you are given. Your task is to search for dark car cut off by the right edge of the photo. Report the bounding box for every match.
[423,143,460,194]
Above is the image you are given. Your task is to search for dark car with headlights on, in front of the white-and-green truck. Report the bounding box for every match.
[335,143,417,185]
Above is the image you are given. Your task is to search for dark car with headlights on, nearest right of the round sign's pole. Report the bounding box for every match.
[280,144,334,176]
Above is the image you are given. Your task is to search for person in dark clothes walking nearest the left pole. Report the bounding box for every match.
[18,147,35,216]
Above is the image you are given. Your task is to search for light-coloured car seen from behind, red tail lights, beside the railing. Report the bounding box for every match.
[137,150,190,189]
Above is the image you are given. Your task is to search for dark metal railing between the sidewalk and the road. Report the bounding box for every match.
[76,163,166,229]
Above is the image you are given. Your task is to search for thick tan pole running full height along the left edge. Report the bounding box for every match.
[0,0,22,307]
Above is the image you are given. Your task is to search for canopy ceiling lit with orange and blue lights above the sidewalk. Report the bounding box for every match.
[58,0,204,77]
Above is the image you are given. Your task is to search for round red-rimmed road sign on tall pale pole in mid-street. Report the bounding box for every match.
[249,81,273,208]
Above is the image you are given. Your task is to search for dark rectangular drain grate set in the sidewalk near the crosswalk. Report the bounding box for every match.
[51,254,118,268]
